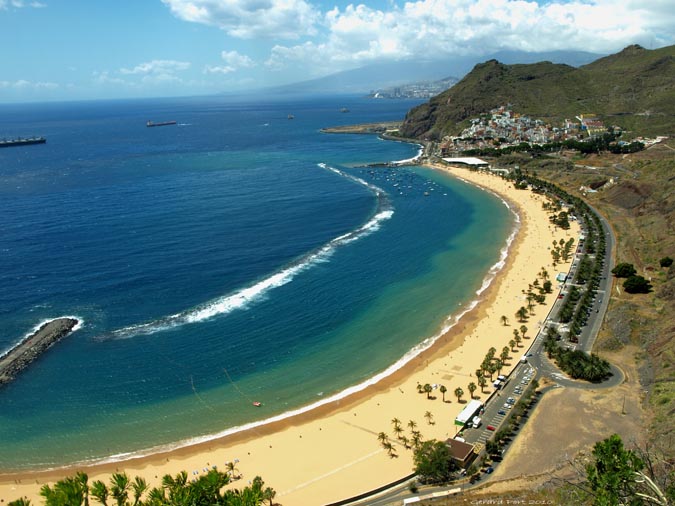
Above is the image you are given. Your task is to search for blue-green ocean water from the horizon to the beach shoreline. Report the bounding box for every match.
[0,96,514,470]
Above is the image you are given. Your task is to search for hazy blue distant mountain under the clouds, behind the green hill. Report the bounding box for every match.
[265,51,600,94]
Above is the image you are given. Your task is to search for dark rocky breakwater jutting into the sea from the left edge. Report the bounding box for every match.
[0,318,79,386]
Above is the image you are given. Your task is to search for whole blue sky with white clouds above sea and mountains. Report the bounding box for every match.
[0,0,675,103]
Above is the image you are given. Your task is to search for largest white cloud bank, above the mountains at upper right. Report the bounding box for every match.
[266,0,675,71]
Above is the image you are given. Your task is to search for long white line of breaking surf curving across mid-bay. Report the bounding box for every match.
[99,164,394,339]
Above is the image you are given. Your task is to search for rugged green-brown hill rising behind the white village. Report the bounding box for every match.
[401,45,675,139]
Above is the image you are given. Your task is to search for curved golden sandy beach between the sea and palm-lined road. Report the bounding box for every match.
[0,167,579,506]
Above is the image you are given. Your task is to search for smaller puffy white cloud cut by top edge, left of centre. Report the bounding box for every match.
[162,0,320,39]
